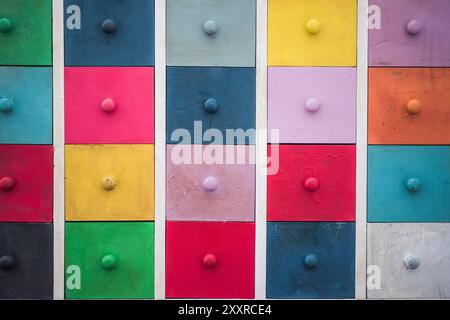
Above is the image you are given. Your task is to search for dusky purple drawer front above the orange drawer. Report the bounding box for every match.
[369,0,450,67]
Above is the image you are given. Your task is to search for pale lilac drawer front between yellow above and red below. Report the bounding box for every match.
[268,67,356,143]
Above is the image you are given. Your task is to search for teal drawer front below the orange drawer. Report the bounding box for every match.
[367,146,450,222]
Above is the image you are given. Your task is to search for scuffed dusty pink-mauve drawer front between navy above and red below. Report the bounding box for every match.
[166,144,255,221]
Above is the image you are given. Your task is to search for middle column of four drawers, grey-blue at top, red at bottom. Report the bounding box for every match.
[166,0,256,298]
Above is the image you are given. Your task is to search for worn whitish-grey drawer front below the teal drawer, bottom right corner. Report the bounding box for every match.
[367,223,450,299]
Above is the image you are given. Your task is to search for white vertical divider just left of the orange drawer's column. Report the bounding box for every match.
[355,0,368,299]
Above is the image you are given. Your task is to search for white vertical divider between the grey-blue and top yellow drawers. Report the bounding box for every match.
[255,0,267,299]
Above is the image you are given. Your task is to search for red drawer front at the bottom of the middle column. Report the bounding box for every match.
[166,222,255,299]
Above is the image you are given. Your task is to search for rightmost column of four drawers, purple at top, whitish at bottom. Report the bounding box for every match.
[367,0,450,299]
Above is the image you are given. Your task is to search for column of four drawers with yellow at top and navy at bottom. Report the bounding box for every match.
[267,0,357,299]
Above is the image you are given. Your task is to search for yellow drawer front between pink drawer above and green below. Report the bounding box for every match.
[66,145,154,221]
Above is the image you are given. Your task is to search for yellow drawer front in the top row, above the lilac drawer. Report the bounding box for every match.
[268,0,357,66]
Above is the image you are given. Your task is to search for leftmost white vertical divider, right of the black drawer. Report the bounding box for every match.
[52,0,65,300]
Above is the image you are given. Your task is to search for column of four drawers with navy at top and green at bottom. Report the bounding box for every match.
[64,0,154,299]
